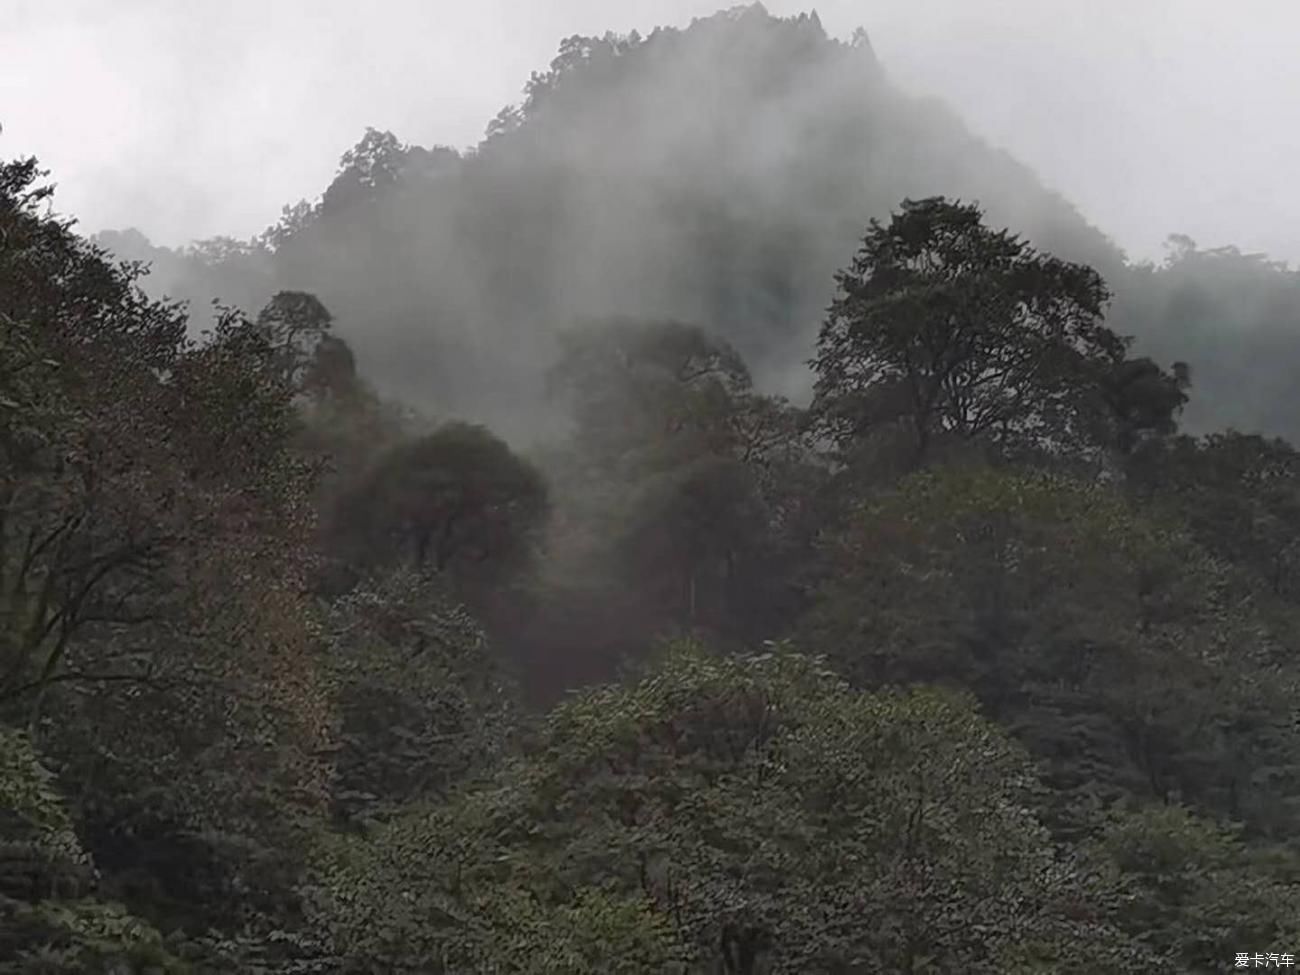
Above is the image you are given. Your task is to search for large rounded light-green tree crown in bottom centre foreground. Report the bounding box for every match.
[317,646,1138,972]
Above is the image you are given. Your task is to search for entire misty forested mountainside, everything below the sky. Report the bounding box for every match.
[0,7,1300,975]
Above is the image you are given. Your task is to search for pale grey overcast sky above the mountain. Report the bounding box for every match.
[0,0,1300,263]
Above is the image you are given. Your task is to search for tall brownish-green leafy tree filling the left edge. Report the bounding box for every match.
[0,163,328,956]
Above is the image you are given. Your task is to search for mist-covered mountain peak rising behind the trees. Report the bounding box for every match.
[104,5,1123,437]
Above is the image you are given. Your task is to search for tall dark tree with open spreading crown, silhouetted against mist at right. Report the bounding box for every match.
[813,198,1182,460]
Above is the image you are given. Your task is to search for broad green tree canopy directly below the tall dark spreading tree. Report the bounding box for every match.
[809,468,1295,842]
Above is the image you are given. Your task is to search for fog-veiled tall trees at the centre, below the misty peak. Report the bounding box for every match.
[535,320,809,657]
